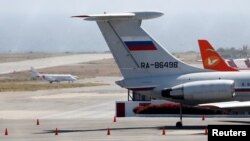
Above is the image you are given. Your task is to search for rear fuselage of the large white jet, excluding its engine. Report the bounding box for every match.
[117,72,250,105]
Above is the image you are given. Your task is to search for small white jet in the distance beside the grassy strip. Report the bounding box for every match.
[31,67,78,83]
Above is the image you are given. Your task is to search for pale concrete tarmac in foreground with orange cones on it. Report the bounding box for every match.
[0,77,250,141]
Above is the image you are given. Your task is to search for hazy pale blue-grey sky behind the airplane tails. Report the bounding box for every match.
[0,0,250,52]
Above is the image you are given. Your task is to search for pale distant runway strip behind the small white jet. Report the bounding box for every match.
[0,53,112,74]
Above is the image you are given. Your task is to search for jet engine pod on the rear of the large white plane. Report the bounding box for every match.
[161,80,235,101]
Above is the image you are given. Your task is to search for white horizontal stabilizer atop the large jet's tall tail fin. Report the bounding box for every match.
[72,12,163,21]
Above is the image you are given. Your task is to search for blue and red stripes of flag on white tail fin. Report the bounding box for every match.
[124,41,157,51]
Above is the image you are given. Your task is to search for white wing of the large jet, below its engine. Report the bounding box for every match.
[198,101,250,109]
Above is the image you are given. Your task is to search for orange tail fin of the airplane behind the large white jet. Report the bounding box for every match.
[198,40,238,71]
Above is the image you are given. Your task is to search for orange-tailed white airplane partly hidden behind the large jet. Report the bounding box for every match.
[198,40,250,71]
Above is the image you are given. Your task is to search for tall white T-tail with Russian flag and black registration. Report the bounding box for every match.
[73,12,204,78]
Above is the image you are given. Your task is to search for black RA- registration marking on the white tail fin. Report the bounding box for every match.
[140,62,178,69]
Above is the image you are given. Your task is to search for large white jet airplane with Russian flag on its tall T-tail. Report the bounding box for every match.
[73,12,250,127]
